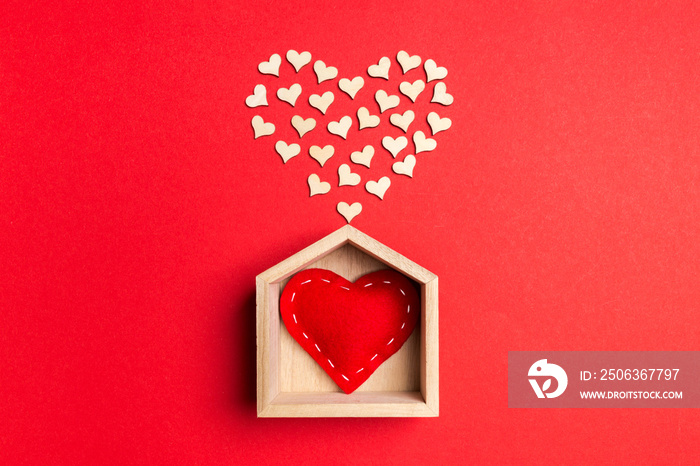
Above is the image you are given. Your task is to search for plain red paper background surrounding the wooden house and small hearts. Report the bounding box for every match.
[0,0,700,464]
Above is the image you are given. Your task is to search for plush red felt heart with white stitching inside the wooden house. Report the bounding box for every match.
[280,269,420,393]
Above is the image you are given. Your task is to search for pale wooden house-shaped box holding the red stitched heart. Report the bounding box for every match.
[256,225,439,417]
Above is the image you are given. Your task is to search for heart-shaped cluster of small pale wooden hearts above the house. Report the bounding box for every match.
[245,50,454,223]
